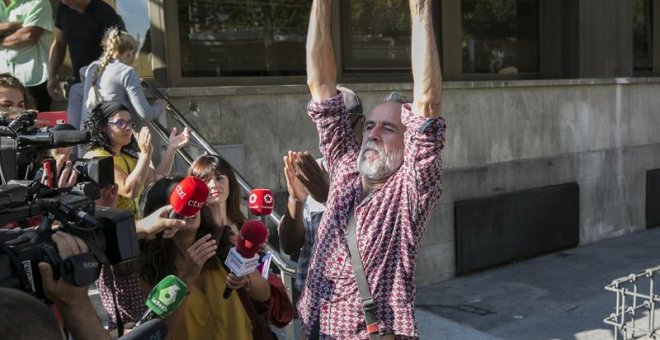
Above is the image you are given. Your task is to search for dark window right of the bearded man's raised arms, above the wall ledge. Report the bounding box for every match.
[461,0,539,74]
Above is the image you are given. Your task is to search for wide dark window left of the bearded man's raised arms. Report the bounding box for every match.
[178,0,311,77]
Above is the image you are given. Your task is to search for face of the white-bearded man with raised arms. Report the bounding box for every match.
[358,103,406,180]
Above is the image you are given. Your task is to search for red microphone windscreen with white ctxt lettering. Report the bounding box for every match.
[170,176,209,217]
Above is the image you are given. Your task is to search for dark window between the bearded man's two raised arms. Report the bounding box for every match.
[341,0,410,73]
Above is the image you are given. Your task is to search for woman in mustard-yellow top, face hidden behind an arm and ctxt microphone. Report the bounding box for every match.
[140,177,270,339]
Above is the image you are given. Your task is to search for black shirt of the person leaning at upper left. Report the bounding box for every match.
[55,0,126,82]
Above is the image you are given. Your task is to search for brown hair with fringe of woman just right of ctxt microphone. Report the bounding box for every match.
[188,155,247,229]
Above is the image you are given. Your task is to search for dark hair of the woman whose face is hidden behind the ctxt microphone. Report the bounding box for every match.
[139,176,232,285]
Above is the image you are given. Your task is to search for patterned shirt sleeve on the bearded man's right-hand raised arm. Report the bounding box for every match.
[401,104,446,237]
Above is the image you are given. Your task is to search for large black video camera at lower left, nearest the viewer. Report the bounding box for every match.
[0,184,139,299]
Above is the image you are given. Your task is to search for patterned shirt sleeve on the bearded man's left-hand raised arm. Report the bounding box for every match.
[307,94,360,173]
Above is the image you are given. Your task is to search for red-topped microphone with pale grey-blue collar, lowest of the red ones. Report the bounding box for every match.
[222,220,268,299]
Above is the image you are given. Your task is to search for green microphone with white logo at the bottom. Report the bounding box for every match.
[135,275,188,327]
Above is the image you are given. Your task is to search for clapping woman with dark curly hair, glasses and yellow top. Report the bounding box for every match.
[84,102,190,217]
